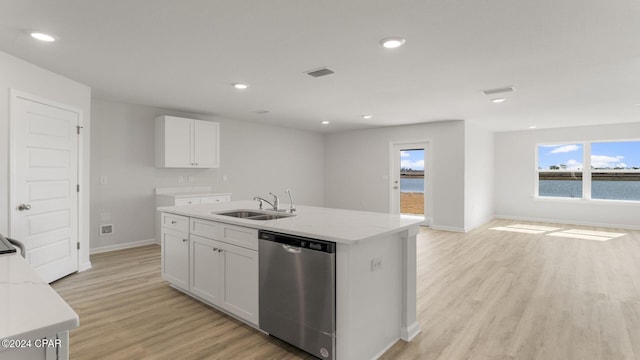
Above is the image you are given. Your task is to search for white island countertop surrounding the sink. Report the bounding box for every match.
[158,201,423,244]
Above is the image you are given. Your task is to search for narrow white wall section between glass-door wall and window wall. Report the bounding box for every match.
[464,121,495,231]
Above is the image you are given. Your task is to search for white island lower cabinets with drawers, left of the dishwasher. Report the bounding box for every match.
[162,214,258,327]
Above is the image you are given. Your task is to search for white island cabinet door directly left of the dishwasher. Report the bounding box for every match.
[219,243,258,326]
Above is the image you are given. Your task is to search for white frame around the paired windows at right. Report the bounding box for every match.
[533,139,640,204]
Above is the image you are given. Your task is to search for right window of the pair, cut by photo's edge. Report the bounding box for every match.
[591,141,640,201]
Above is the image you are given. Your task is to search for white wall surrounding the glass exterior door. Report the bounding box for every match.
[324,120,465,231]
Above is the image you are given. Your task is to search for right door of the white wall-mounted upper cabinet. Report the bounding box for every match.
[192,120,220,168]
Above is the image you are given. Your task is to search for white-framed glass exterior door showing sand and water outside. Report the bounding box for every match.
[390,141,431,226]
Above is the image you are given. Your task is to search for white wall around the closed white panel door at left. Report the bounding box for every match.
[0,51,91,269]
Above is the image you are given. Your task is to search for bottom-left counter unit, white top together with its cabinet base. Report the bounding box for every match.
[0,254,79,360]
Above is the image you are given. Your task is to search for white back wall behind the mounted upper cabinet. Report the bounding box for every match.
[91,99,324,248]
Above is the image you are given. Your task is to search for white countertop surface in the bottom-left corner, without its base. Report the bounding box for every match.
[0,254,80,339]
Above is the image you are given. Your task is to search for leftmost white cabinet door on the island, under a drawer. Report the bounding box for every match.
[161,229,189,290]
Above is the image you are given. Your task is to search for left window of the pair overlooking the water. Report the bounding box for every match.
[538,144,583,198]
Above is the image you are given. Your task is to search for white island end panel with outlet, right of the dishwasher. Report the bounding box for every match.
[336,233,404,360]
